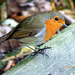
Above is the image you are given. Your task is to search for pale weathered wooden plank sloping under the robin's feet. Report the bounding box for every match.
[3,23,75,75]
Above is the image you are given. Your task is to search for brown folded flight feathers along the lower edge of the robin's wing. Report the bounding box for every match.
[11,28,36,39]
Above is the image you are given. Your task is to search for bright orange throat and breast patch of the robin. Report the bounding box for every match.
[44,19,62,42]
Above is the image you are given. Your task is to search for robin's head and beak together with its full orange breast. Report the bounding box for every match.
[44,12,67,41]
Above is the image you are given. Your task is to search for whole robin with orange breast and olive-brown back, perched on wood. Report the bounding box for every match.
[0,11,67,52]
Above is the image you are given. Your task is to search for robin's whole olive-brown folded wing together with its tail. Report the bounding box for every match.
[0,15,44,41]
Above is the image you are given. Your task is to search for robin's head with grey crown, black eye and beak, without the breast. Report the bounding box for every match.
[47,11,67,27]
